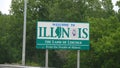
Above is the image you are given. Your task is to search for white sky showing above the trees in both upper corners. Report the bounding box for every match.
[0,0,118,14]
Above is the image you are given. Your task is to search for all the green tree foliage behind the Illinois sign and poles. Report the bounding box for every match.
[0,0,120,68]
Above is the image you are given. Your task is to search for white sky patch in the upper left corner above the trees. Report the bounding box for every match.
[0,0,11,14]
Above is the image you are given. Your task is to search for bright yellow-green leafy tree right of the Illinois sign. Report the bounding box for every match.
[64,16,120,68]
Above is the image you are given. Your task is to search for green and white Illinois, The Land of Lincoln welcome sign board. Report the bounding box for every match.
[36,21,90,50]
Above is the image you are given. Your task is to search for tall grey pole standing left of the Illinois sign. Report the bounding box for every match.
[22,0,27,65]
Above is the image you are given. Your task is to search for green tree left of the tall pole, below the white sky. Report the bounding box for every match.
[0,15,21,63]
